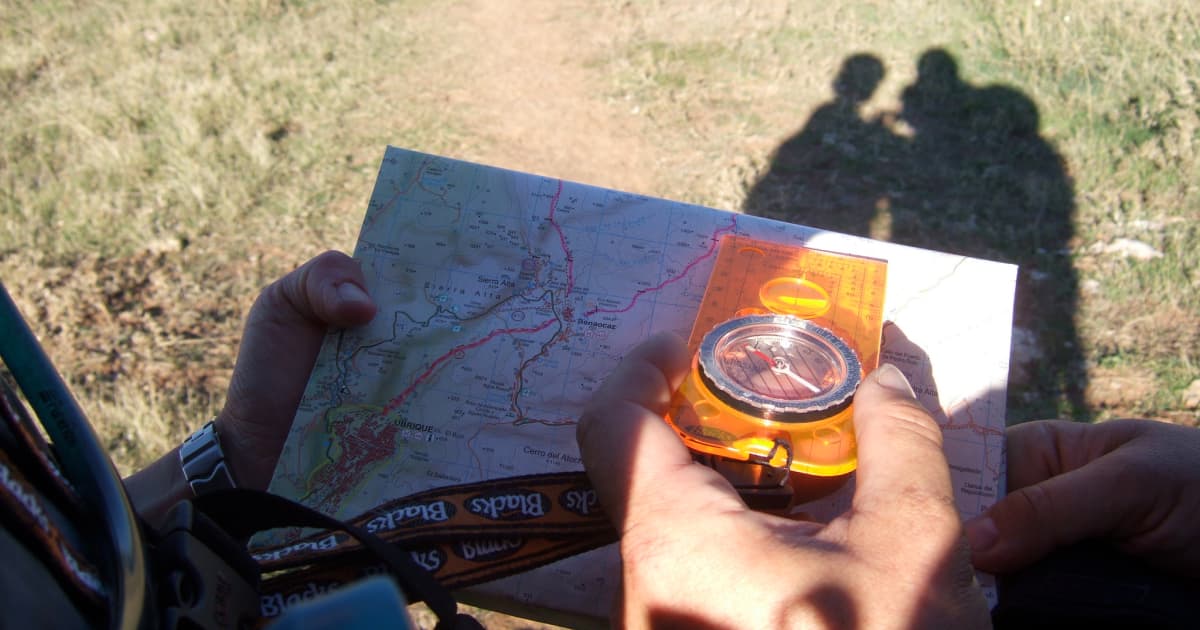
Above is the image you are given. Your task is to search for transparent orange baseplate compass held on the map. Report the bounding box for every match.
[666,235,887,509]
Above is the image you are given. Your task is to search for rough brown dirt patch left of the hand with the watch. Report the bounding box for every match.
[0,245,250,453]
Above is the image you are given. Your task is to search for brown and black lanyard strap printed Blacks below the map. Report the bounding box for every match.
[252,472,617,619]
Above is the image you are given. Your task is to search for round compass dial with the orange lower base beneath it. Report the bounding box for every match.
[666,314,863,476]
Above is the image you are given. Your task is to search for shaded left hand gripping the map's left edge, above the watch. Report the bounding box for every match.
[216,251,376,490]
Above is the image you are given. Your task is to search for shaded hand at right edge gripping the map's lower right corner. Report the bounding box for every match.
[967,420,1200,577]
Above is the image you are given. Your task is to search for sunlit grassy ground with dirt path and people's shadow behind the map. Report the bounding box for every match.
[0,0,1200,619]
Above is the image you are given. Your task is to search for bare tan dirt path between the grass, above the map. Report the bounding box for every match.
[422,0,656,192]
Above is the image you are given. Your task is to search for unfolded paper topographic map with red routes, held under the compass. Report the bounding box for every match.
[270,148,1016,617]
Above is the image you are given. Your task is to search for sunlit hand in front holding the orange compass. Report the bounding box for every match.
[577,336,989,628]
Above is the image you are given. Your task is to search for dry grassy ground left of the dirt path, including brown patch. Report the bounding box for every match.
[0,1,477,469]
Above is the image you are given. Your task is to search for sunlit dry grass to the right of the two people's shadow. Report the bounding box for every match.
[964,2,1200,418]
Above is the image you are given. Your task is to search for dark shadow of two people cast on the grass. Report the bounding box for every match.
[744,48,1091,420]
